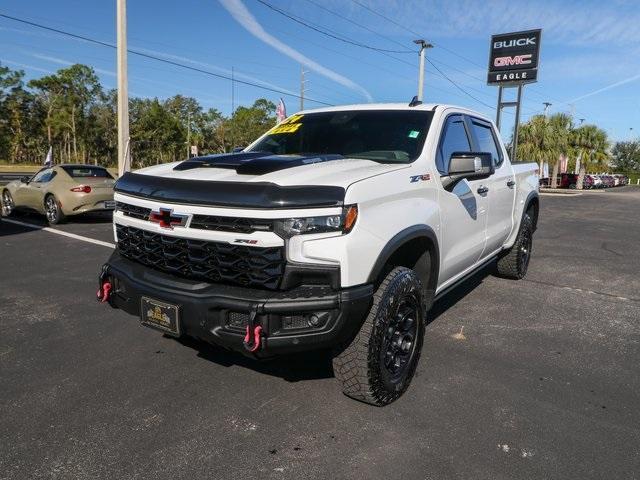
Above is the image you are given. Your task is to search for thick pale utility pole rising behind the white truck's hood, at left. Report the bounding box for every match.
[116,0,131,176]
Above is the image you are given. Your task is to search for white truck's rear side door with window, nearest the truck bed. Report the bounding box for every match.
[469,117,516,257]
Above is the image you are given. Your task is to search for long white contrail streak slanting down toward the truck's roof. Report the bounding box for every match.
[219,0,373,102]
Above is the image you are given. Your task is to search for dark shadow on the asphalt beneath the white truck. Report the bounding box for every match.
[170,262,496,382]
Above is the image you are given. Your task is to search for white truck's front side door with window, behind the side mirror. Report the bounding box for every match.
[436,114,487,286]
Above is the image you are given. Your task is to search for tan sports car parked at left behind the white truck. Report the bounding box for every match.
[1,165,115,225]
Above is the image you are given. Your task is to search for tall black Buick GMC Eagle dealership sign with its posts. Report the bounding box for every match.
[487,29,542,162]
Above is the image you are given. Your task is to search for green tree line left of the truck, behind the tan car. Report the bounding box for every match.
[0,64,276,168]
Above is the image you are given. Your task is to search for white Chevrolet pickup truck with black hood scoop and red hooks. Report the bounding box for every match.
[98,103,539,405]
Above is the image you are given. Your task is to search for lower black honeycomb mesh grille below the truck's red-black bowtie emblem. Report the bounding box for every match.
[116,224,285,290]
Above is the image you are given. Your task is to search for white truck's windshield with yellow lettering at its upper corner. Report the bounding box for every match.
[246,110,433,163]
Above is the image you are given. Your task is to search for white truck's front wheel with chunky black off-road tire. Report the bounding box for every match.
[333,267,426,406]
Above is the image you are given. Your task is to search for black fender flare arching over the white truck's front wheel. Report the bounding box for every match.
[368,225,440,308]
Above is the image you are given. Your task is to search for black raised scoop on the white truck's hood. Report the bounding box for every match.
[173,152,344,175]
